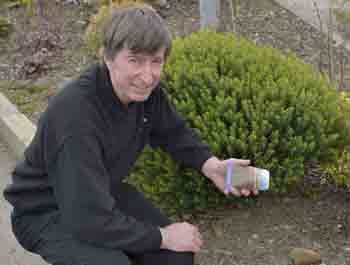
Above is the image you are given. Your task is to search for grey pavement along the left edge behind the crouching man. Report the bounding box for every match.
[0,139,45,265]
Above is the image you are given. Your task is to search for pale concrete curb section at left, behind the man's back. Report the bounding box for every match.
[0,93,36,159]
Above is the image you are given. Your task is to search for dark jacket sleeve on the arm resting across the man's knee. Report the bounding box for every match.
[48,133,161,253]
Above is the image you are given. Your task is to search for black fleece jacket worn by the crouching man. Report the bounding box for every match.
[4,64,211,253]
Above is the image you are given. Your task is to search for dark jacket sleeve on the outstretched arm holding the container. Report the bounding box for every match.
[151,87,212,170]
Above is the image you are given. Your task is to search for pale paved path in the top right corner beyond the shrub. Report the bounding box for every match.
[274,0,350,50]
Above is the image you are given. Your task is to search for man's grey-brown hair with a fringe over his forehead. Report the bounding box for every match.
[103,5,172,60]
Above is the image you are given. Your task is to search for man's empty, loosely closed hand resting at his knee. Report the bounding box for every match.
[160,222,203,252]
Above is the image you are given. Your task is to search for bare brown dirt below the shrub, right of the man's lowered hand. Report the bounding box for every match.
[191,191,350,265]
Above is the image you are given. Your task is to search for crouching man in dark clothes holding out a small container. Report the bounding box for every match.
[4,6,256,265]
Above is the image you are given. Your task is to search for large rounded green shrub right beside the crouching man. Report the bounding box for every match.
[131,32,350,214]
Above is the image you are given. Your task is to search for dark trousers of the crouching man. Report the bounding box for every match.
[10,183,194,265]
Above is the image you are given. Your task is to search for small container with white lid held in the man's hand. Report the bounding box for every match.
[225,163,270,193]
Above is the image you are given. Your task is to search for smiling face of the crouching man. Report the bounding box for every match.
[106,48,165,104]
